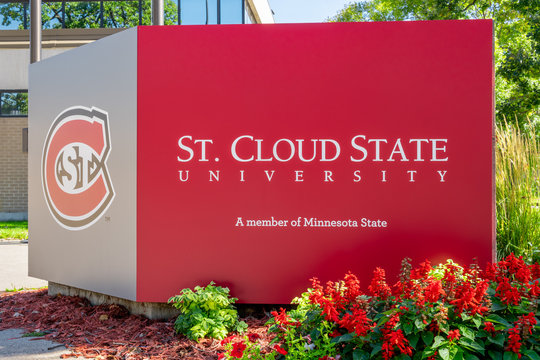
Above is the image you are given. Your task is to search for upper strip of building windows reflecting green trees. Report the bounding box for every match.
[0,0,178,29]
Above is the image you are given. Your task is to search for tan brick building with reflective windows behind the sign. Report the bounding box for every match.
[0,0,274,221]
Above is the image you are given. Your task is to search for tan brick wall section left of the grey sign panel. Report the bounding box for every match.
[0,117,28,213]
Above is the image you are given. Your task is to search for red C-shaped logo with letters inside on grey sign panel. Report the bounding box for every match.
[41,106,115,230]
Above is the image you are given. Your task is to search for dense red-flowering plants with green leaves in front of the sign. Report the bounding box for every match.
[222,255,540,360]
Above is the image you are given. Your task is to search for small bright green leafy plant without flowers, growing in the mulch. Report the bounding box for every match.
[169,282,247,340]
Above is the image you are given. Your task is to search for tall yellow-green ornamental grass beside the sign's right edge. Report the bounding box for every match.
[495,120,540,261]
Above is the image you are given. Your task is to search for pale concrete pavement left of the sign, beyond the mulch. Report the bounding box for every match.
[0,240,47,292]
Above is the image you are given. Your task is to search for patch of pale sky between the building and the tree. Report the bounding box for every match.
[268,0,353,23]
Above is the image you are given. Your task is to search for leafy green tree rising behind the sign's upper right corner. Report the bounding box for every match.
[330,0,540,126]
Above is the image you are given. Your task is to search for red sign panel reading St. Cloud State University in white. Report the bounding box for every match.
[137,21,494,303]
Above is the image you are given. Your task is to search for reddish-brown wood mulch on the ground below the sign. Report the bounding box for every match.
[0,289,271,360]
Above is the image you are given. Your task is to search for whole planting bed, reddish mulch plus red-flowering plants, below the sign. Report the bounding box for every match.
[0,255,540,360]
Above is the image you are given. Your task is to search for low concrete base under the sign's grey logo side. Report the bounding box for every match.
[49,281,180,320]
